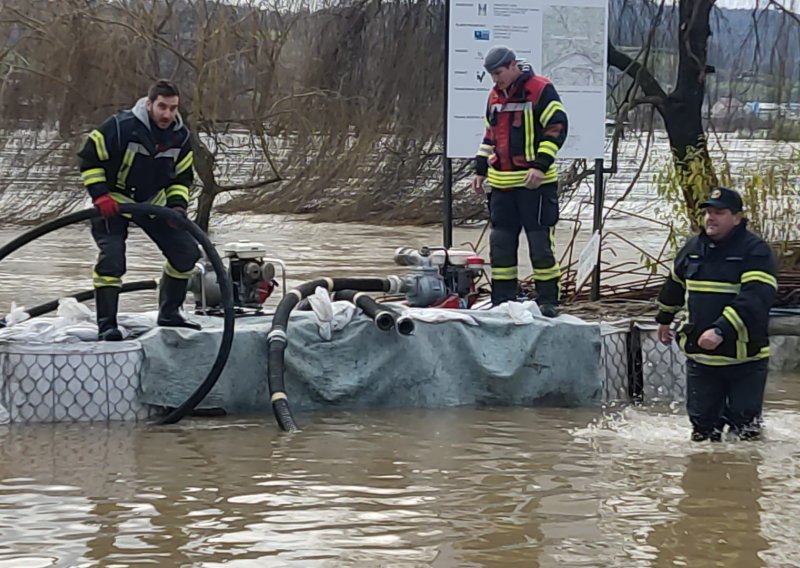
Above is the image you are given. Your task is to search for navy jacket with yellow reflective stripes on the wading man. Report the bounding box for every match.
[656,220,778,365]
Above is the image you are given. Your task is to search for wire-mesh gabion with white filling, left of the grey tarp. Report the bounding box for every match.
[0,343,150,423]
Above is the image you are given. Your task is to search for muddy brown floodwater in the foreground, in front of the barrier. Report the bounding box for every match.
[0,375,800,568]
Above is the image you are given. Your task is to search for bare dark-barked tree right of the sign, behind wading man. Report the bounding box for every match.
[608,0,798,225]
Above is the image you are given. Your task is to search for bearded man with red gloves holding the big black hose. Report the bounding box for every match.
[78,80,200,341]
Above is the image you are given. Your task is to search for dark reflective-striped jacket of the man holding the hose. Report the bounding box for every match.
[78,98,193,209]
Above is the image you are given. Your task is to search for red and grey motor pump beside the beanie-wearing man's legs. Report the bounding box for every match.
[394,247,485,308]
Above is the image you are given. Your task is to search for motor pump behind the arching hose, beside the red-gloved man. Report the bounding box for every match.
[188,241,286,312]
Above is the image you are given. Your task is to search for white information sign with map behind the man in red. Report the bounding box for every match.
[446,0,608,159]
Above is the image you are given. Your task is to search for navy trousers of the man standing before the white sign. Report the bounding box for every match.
[489,183,561,305]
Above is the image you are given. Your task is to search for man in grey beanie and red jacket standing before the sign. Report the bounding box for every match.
[472,46,567,317]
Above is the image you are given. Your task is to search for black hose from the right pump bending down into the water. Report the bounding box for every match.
[267,276,403,432]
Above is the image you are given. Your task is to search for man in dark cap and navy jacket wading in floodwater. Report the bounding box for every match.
[656,187,778,441]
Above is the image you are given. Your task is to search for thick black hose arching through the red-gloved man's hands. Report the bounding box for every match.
[0,203,234,424]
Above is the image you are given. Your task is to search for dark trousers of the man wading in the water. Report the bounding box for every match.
[686,359,769,438]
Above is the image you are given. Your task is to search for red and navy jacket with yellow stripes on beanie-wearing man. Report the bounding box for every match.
[475,65,568,189]
